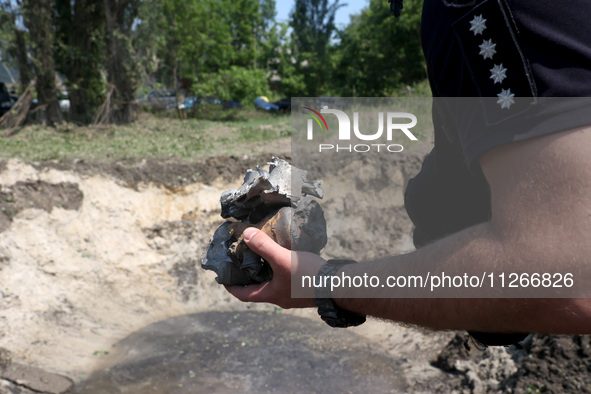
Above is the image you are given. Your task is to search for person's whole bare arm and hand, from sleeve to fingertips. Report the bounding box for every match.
[229,128,591,333]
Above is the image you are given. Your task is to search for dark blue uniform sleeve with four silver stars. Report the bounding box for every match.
[422,0,591,165]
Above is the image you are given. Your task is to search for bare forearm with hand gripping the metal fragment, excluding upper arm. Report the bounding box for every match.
[228,214,591,334]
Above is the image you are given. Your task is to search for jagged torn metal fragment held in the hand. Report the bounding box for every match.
[201,158,326,285]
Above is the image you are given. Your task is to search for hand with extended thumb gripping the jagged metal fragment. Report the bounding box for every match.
[226,227,326,309]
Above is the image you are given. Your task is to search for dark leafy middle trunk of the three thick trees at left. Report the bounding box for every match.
[55,0,105,123]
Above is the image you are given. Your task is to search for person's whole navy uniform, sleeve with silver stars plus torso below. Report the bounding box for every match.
[402,0,591,345]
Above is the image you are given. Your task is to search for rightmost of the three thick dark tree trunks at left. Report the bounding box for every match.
[104,0,140,123]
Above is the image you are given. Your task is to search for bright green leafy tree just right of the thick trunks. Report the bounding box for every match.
[136,0,261,90]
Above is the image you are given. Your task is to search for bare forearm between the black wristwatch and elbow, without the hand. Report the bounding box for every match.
[333,223,591,334]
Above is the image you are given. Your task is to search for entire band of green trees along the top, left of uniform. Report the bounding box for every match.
[0,0,429,131]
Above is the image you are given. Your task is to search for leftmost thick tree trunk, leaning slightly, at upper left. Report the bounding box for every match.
[22,0,63,126]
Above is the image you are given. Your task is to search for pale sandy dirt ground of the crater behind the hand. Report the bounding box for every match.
[0,146,591,393]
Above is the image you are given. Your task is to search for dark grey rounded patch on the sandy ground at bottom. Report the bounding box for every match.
[75,312,407,394]
